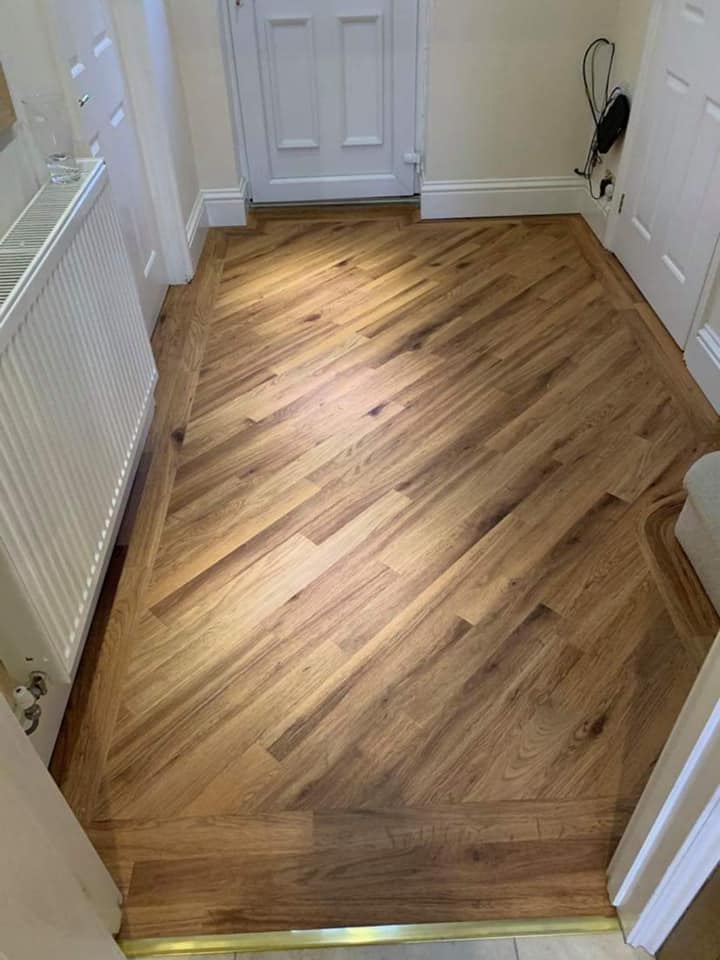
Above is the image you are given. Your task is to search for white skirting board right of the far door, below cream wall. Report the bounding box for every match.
[421,176,587,220]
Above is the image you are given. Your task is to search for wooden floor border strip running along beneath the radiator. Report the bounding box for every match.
[51,233,225,824]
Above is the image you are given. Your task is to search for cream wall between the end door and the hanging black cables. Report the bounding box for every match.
[426,0,618,180]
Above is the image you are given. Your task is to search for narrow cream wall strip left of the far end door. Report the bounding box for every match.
[167,0,239,189]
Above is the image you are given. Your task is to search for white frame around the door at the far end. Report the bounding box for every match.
[216,0,435,203]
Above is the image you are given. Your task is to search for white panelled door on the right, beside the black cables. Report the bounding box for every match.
[615,0,720,346]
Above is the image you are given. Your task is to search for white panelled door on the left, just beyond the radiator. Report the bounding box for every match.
[49,0,167,330]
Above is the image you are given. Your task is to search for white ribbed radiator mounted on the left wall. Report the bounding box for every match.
[0,161,157,753]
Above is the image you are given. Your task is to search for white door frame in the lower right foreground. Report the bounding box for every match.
[608,636,720,955]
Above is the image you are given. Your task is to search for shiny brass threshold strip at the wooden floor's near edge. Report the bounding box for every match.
[119,917,620,957]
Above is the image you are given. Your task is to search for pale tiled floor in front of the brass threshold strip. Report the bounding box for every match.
[160,933,647,960]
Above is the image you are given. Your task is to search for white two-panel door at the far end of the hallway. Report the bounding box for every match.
[228,0,418,202]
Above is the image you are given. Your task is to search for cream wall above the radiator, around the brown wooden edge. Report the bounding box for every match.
[0,0,61,235]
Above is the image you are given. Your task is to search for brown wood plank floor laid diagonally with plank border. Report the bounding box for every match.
[55,207,718,937]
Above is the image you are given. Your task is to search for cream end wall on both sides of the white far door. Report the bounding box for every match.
[169,0,652,206]
